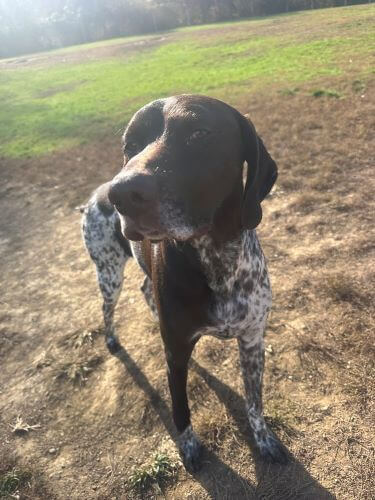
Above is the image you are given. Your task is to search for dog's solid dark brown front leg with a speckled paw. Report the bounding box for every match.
[166,344,201,472]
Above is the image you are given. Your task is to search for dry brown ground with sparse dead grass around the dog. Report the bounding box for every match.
[0,77,375,500]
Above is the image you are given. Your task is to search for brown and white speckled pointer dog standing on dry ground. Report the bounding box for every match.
[82,95,287,471]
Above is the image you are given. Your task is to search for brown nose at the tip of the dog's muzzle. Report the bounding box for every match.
[108,174,157,217]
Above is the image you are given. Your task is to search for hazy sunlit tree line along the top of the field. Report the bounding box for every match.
[0,0,371,57]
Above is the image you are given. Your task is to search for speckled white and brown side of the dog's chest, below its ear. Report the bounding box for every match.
[194,231,271,339]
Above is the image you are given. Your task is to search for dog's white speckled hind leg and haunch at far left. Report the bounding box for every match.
[82,188,131,354]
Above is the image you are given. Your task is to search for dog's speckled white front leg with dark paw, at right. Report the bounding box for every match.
[238,328,287,463]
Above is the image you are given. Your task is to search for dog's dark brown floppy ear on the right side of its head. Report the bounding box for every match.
[238,113,277,229]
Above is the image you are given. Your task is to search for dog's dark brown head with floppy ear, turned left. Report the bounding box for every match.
[109,95,277,240]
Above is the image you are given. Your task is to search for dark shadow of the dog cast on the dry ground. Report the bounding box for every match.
[115,347,335,500]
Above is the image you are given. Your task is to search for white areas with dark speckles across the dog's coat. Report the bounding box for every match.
[82,195,284,469]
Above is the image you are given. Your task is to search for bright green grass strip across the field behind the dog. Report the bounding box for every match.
[0,2,375,157]
